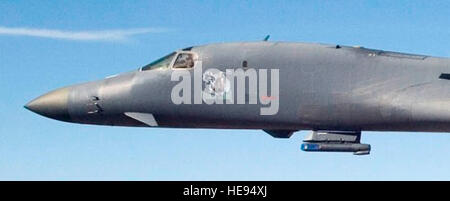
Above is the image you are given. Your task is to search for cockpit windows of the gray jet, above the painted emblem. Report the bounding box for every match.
[141,51,196,71]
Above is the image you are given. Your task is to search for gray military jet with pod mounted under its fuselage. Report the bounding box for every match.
[25,41,450,155]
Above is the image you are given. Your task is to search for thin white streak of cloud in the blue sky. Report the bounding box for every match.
[0,26,168,41]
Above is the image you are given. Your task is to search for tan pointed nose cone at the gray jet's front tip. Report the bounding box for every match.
[24,88,70,121]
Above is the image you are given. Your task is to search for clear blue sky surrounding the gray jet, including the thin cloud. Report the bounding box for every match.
[0,0,450,180]
